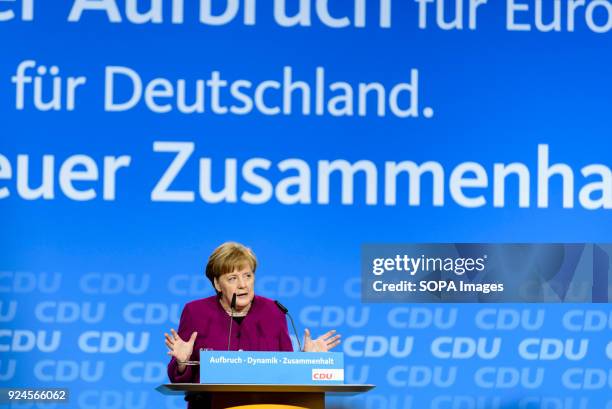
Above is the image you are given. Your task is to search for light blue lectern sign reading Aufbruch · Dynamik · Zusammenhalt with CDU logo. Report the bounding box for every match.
[200,350,344,385]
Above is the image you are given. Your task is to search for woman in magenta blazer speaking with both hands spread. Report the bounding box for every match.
[165,242,340,383]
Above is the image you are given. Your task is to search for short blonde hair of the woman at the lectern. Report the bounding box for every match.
[206,241,257,291]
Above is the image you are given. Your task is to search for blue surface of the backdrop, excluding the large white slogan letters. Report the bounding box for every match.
[0,0,612,409]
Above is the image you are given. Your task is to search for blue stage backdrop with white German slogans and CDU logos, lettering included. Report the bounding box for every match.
[0,0,612,409]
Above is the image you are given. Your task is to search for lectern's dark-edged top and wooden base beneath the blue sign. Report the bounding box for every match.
[157,383,374,409]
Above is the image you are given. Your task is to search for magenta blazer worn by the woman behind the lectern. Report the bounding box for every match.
[168,295,293,383]
